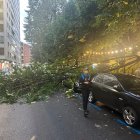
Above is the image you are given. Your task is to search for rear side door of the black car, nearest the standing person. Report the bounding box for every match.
[92,74,104,102]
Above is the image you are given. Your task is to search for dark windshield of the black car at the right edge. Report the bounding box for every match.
[118,76,140,90]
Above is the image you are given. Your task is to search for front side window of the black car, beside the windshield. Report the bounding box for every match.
[103,74,119,87]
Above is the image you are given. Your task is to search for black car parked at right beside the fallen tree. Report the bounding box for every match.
[75,73,140,126]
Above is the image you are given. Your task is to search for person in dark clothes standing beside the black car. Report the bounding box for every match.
[79,68,91,117]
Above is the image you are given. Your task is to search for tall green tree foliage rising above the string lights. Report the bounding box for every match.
[25,0,140,62]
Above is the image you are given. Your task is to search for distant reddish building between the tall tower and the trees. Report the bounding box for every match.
[21,43,31,66]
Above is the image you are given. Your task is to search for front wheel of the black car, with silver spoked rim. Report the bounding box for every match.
[123,107,138,126]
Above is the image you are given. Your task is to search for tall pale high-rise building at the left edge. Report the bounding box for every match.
[0,0,21,68]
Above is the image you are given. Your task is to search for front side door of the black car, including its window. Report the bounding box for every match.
[103,74,124,110]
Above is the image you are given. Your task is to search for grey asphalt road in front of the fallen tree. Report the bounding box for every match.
[0,94,140,140]
